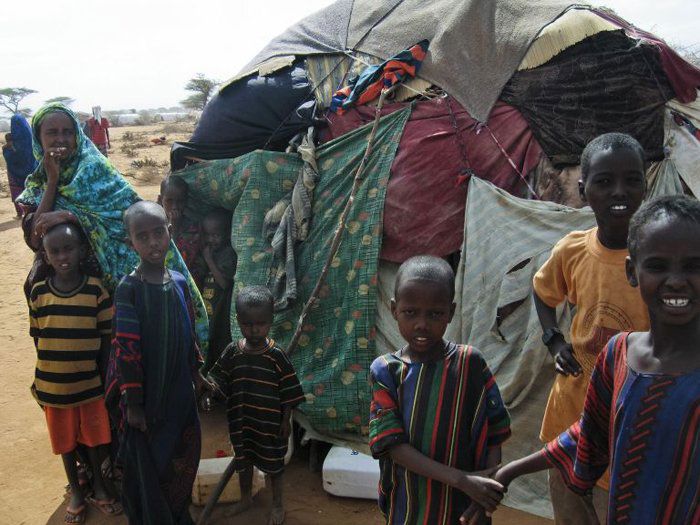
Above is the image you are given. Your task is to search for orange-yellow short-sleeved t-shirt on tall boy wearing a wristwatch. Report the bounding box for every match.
[533,228,649,485]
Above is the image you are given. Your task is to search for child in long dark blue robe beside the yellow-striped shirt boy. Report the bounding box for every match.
[107,201,211,523]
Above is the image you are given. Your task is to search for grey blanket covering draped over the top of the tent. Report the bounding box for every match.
[241,0,576,122]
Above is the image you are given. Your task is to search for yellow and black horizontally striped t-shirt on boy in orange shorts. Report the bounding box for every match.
[29,276,112,408]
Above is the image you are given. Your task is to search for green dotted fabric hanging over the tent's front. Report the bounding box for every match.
[177,108,410,439]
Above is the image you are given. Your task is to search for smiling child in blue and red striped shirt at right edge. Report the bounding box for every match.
[496,196,700,525]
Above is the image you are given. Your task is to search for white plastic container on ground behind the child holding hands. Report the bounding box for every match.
[323,445,379,500]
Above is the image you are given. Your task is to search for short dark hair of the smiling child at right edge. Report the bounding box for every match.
[627,195,700,259]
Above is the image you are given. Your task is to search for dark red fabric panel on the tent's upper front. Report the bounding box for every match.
[322,98,542,263]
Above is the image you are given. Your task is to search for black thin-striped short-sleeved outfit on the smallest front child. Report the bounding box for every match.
[211,339,304,474]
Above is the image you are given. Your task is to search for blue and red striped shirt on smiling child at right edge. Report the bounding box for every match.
[543,333,700,525]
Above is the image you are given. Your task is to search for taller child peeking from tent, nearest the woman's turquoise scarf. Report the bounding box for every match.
[158,174,202,286]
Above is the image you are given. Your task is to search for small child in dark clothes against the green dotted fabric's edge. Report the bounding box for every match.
[197,208,238,373]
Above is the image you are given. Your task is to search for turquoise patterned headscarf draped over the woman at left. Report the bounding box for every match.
[17,103,208,352]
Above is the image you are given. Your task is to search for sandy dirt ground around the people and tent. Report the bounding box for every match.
[0,124,552,525]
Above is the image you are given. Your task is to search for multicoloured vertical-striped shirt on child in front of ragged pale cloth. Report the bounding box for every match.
[369,342,510,525]
